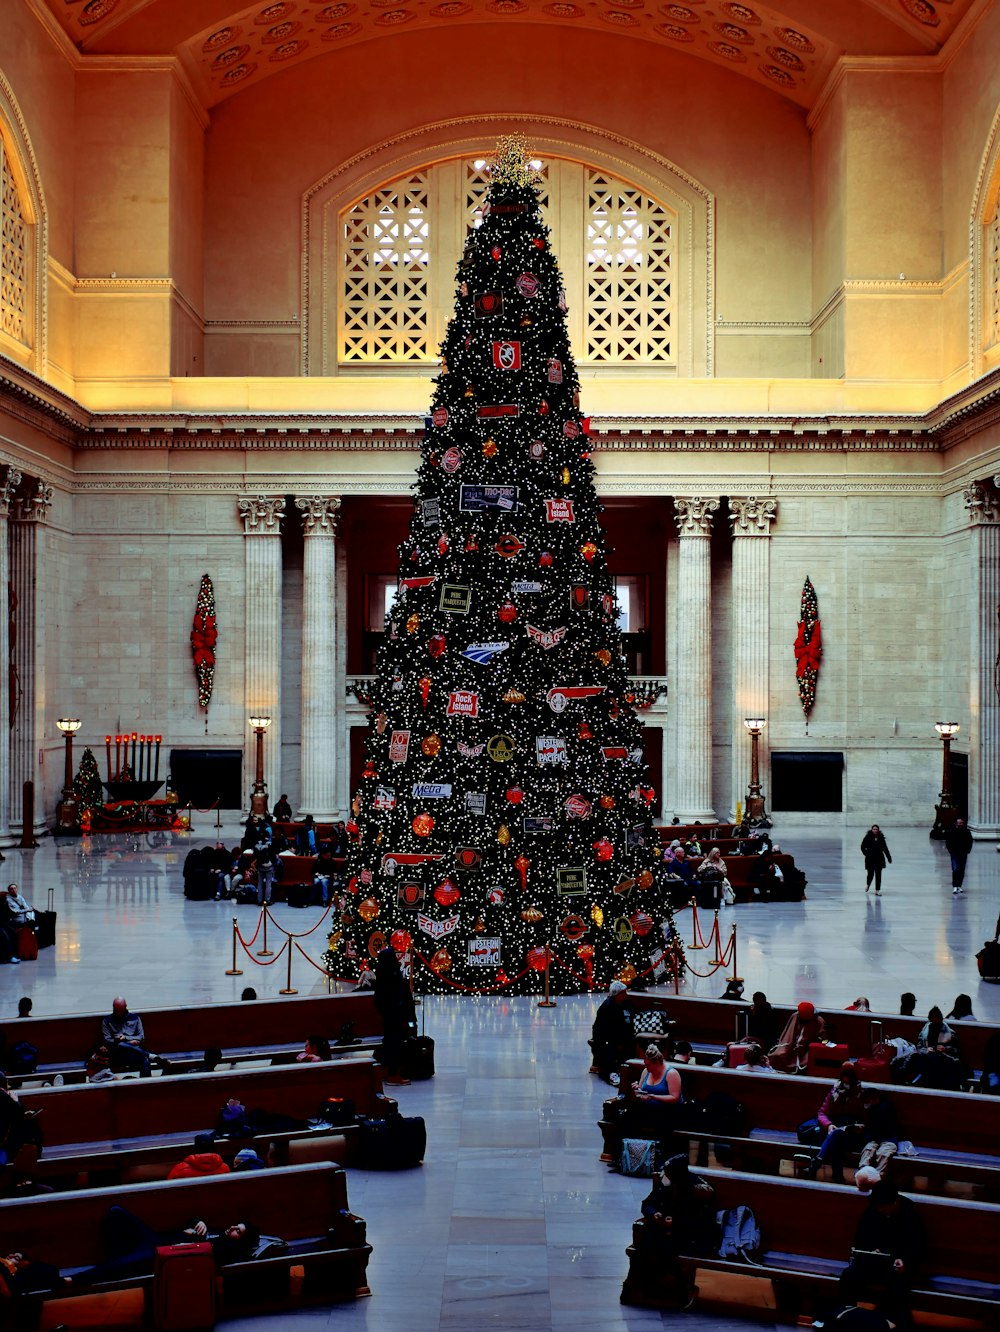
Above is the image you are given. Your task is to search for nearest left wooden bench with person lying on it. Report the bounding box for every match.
[0,1164,372,1325]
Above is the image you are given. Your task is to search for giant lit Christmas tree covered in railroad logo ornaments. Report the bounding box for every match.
[328,139,679,994]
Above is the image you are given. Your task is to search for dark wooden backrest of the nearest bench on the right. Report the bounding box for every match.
[696,1169,1000,1284]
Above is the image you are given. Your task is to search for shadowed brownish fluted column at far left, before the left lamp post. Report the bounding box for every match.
[9,481,52,833]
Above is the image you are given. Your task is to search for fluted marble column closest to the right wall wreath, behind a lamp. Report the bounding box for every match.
[730,496,778,810]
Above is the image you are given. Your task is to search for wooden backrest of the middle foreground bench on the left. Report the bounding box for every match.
[20,1059,382,1147]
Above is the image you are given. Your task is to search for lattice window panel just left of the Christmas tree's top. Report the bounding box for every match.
[340,172,434,364]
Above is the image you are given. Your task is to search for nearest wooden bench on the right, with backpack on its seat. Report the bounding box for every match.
[622,1169,1000,1327]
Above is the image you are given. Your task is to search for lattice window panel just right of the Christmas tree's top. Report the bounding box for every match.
[583,170,676,365]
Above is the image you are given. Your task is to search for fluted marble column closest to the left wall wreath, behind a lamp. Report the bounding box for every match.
[238,496,285,809]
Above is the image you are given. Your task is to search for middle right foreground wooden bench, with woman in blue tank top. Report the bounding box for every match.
[601,1060,1000,1197]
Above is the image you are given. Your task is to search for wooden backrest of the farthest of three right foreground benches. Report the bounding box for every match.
[628,996,1000,1068]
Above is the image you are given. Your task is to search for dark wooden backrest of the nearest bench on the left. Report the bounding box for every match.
[0,1163,348,1267]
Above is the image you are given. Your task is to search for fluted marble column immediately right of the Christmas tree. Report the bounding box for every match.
[671,497,719,823]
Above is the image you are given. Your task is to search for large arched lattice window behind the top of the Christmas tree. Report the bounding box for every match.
[338,157,679,374]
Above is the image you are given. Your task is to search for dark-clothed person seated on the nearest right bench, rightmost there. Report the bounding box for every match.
[838,1180,923,1328]
